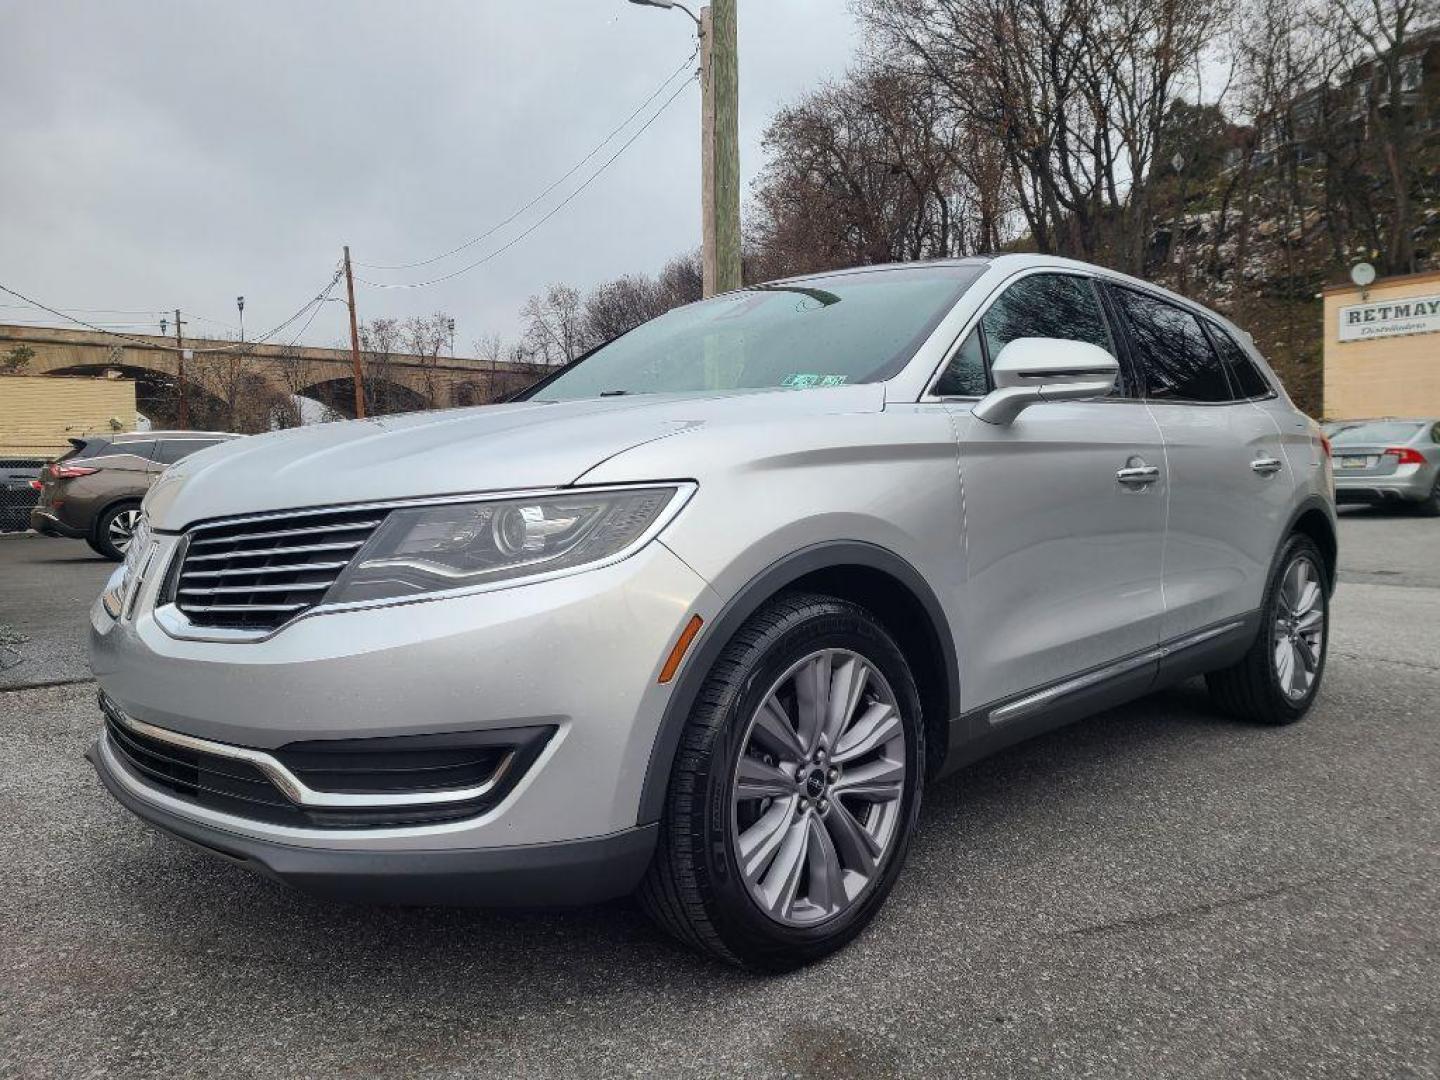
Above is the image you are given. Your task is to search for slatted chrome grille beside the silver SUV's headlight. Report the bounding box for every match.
[174,510,386,629]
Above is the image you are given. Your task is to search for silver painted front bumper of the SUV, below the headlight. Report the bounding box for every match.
[91,536,719,869]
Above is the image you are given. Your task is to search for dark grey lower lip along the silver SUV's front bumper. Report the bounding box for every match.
[85,734,660,907]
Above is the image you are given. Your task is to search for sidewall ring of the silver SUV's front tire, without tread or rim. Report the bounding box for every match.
[697,602,924,966]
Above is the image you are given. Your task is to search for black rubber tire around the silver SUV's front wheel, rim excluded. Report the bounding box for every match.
[638,593,924,971]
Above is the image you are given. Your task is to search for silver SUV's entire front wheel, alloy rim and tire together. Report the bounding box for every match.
[639,593,924,971]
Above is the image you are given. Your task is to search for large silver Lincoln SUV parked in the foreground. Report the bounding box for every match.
[89,255,1336,969]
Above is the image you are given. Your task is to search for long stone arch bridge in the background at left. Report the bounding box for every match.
[0,324,540,429]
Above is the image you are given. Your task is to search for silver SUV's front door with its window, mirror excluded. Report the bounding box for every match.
[935,271,1168,720]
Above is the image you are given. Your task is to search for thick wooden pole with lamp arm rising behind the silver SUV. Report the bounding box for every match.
[629,0,742,297]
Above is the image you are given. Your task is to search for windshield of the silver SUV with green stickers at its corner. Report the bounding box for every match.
[527,264,985,402]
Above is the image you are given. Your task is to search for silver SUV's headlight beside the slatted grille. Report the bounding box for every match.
[325,487,681,603]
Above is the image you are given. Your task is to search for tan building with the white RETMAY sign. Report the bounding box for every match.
[1323,271,1440,420]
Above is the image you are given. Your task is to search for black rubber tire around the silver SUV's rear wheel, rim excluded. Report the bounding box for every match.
[1205,534,1331,724]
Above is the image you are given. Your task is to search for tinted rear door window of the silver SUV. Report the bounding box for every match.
[1115,288,1234,402]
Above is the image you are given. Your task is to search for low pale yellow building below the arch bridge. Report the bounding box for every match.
[0,374,135,458]
